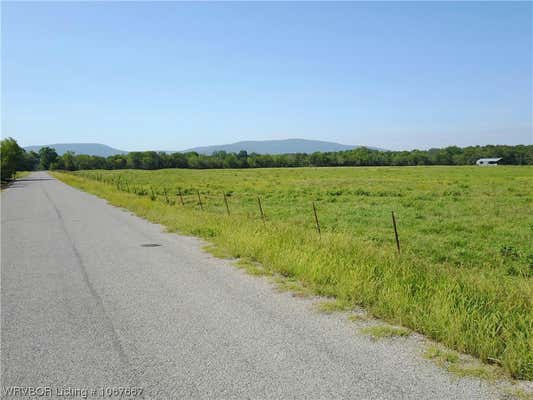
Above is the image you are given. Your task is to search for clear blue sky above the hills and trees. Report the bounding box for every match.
[1,2,533,150]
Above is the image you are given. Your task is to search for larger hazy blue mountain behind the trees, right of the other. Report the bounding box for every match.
[183,139,380,155]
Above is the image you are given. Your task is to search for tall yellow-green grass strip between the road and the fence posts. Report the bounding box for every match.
[54,172,533,380]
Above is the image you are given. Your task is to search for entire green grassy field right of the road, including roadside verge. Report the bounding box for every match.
[55,167,533,380]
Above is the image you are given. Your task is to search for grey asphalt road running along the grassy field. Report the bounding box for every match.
[1,172,499,400]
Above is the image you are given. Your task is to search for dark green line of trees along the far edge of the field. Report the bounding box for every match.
[1,138,533,180]
